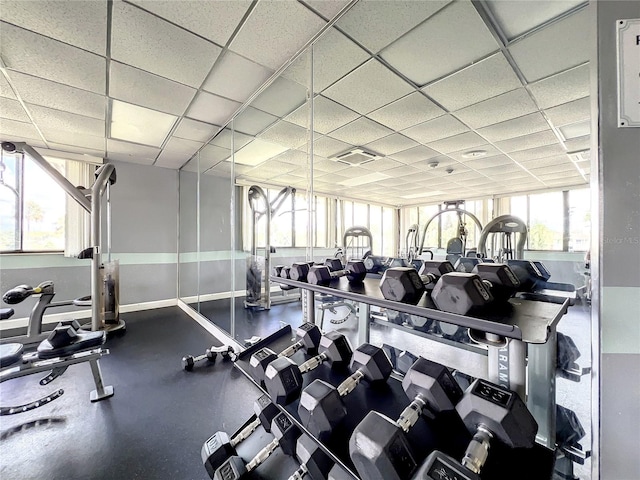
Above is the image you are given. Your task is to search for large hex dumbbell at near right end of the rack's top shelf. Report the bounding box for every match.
[431,263,520,315]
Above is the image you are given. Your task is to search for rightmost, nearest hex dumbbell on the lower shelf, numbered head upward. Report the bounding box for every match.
[413,379,538,480]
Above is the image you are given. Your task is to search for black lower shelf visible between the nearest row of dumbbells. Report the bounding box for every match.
[234,325,554,480]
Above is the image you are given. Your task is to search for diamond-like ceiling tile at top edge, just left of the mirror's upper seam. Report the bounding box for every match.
[230,1,326,70]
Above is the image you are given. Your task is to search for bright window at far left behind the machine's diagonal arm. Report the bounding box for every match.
[0,152,79,254]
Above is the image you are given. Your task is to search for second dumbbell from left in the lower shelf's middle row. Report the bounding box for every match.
[264,330,353,405]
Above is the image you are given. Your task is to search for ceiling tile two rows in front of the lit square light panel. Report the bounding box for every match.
[111,2,222,88]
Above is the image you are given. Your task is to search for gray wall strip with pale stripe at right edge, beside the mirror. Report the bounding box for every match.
[592,1,640,480]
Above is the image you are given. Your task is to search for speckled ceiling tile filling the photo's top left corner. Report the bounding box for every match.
[0,0,107,55]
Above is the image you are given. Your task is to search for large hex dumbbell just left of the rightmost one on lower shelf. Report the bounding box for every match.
[349,357,462,480]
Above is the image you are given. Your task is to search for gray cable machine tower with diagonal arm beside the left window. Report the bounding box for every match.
[2,142,126,332]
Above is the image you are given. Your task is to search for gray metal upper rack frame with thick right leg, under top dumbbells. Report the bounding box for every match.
[274,277,569,450]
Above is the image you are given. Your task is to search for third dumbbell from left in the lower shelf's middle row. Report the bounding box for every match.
[298,343,393,441]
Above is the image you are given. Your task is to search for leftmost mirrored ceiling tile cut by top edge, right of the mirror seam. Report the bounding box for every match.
[337,0,449,53]
